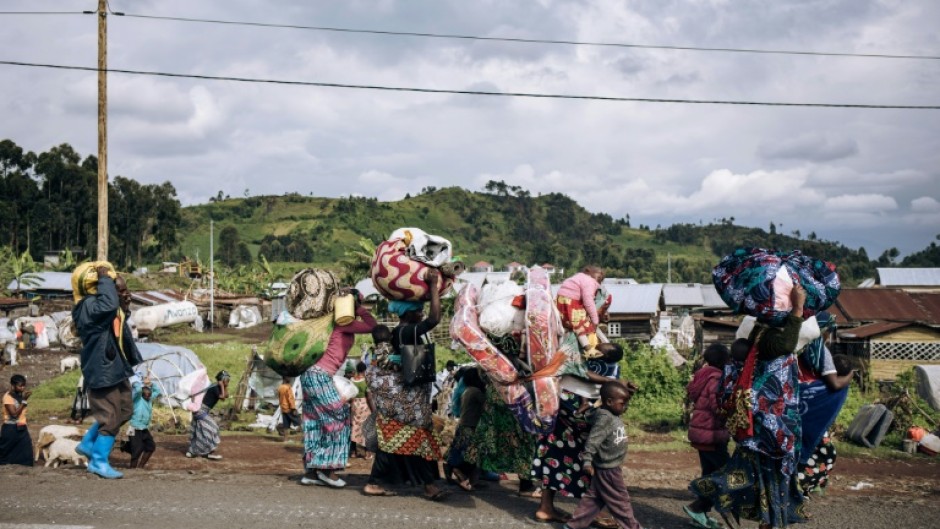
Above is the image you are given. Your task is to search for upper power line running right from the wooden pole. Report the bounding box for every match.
[117,13,940,60]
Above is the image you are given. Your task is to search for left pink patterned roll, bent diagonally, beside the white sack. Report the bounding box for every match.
[450,283,519,384]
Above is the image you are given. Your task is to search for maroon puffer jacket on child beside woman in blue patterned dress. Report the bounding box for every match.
[686,364,731,450]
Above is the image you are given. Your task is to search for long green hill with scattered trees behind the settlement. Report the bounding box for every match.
[180,182,874,286]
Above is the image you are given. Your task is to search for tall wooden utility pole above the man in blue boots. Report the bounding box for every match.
[97,0,108,261]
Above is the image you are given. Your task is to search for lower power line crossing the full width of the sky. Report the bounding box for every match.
[0,61,940,110]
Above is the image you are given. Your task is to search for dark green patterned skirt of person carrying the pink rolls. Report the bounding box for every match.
[464,384,536,479]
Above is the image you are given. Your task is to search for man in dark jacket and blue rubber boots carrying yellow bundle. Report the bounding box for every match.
[72,263,141,479]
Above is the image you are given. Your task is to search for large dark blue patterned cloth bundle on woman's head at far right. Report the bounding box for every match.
[712,248,842,326]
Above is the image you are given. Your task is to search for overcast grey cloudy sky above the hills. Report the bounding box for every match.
[0,0,940,258]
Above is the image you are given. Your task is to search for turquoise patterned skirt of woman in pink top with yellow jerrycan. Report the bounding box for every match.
[300,367,350,470]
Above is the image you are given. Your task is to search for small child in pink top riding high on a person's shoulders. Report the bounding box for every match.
[555,265,604,358]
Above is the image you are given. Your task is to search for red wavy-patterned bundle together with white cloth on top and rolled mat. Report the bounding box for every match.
[369,228,465,301]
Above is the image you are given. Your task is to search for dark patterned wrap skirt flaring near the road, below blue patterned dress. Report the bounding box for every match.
[689,446,806,527]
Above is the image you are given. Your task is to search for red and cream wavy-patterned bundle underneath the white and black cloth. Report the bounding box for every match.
[370,239,454,301]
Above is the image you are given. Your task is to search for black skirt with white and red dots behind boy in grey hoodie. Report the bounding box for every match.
[531,392,591,498]
